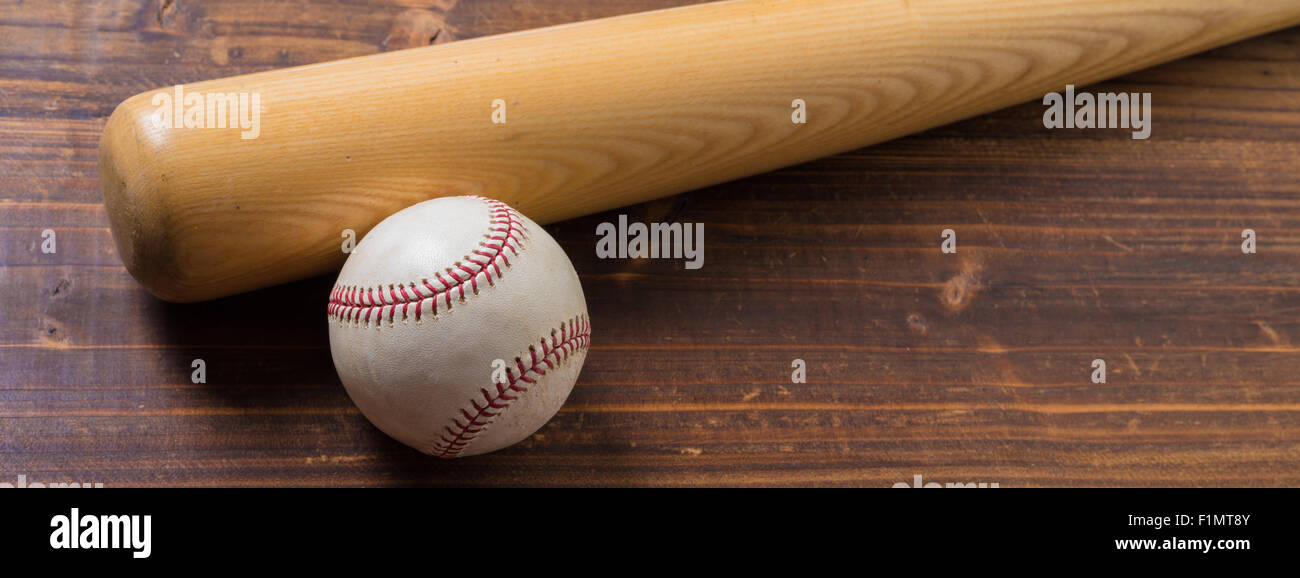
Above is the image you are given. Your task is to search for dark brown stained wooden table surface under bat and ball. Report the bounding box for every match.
[0,0,1300,487]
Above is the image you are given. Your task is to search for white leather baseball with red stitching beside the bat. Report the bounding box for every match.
[329,196,590,457]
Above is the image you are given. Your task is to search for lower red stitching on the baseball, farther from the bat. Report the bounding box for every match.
[434,316,592,457]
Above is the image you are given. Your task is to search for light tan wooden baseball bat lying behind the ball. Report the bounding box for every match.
[100,0,1300,301]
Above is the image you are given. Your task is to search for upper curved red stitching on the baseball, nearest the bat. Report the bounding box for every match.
[326,196,528,325]
